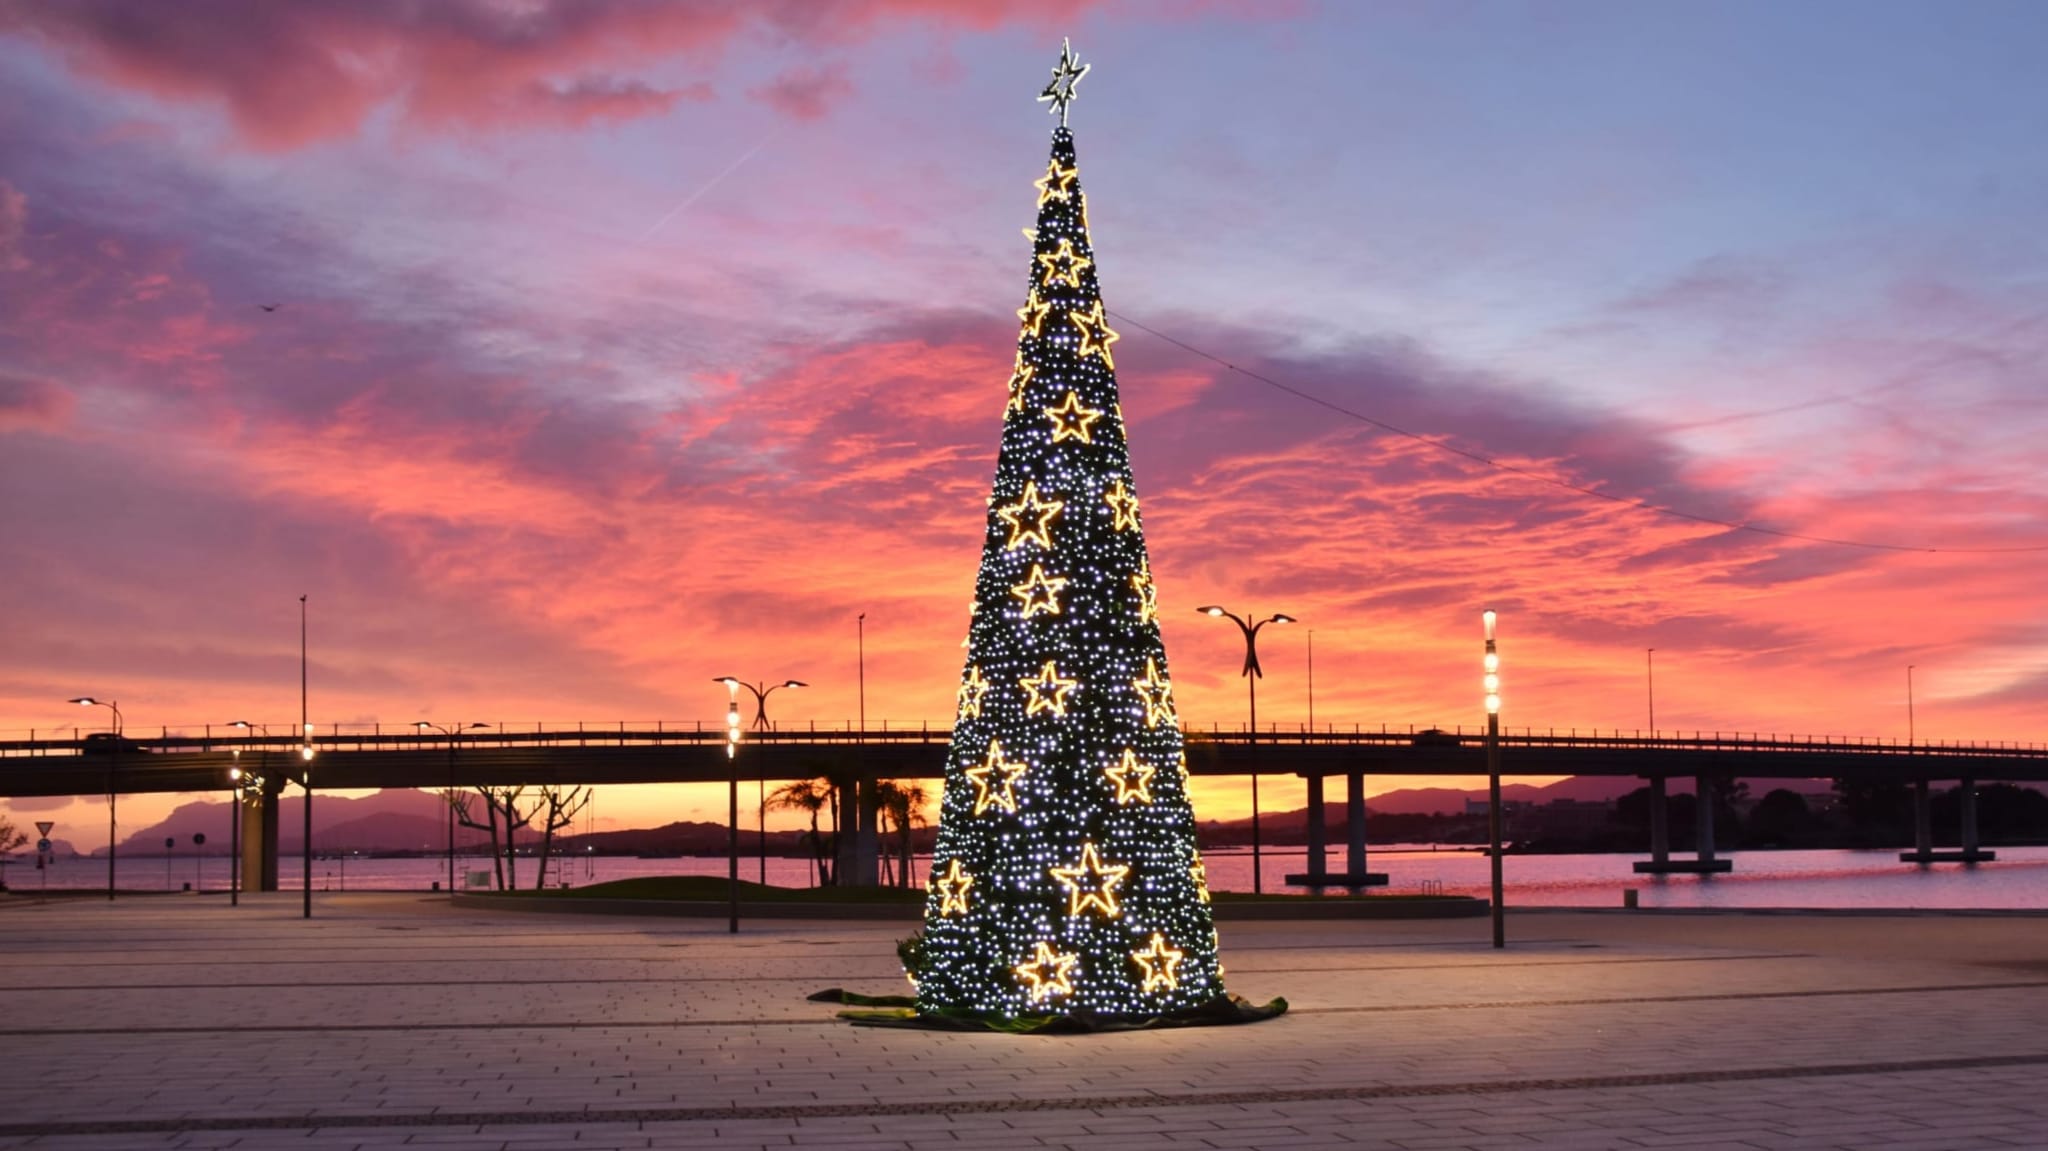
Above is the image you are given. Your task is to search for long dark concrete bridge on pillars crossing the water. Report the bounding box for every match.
[0,723,2048,891]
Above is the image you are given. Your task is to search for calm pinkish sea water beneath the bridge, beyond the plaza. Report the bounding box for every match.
[16,848,2048,909]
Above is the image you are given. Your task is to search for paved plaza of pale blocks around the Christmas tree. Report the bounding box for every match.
[0,895,2048,1151]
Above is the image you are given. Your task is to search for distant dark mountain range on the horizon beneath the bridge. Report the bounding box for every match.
[53,776,1829,856]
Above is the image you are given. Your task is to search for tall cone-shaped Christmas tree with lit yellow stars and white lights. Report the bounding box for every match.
[918,42,1223,1018]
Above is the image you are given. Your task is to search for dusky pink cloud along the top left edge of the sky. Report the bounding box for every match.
[0,0,1094,152]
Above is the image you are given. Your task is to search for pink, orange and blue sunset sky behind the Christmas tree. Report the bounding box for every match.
[0,0,2048,838]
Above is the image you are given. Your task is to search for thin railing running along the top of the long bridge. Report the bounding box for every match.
[0,721,2048,758]
